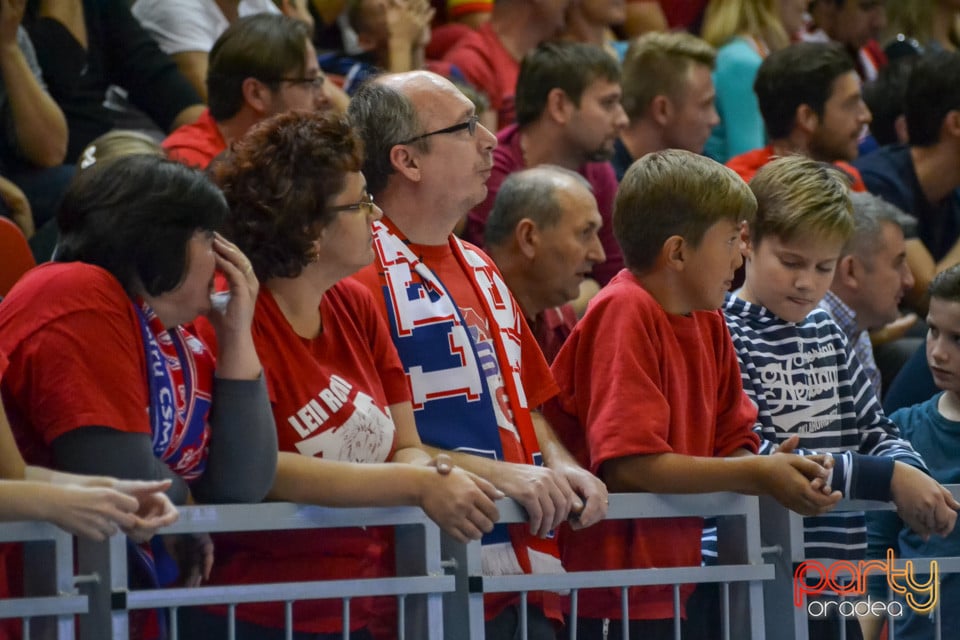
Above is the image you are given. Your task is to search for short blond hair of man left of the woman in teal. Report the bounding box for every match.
[621,31,717,120]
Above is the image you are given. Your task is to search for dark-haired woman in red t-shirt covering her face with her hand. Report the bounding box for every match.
[0,155,276,580]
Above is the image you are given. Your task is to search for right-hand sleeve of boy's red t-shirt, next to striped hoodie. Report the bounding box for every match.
[713,311,760,457]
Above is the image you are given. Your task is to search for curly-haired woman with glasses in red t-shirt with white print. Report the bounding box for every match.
[180,111,501,640]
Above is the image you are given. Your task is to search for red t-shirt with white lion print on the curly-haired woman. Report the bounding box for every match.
[201,279,410,633]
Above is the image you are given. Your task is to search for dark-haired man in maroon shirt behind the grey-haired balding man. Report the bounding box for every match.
[464,42,627,290]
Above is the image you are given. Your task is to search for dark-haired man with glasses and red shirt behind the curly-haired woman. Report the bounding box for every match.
[163,13,331,169]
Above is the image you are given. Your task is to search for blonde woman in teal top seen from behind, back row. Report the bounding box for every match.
[702,0,807,162]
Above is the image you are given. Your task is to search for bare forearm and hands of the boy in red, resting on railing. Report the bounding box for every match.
[600,449,841,515]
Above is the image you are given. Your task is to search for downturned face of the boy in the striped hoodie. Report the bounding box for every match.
[740,228,843,322]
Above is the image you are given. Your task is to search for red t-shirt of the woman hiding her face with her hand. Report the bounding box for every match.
[0,262,161,466]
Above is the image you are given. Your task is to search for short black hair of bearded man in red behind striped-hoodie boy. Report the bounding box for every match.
[753,42,854,139]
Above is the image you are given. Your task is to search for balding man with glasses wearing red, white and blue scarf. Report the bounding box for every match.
[349,71,607,640]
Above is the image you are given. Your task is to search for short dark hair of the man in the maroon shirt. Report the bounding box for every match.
[515,42,620,127]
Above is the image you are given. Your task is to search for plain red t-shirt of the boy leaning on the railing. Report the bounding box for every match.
[544,270,759,619]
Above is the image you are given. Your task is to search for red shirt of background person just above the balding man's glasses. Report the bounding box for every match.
[443,22,520,129]
